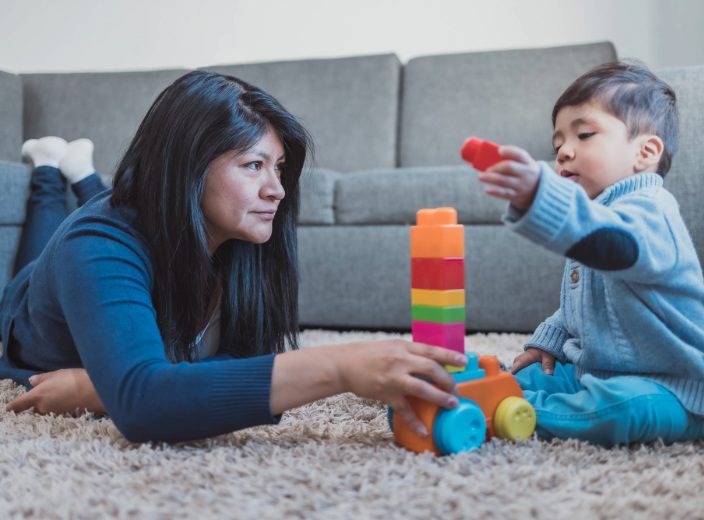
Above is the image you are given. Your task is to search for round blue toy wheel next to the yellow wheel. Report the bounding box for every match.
[433,397,486,455]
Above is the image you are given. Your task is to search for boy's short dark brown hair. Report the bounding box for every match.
[552,61,679,177]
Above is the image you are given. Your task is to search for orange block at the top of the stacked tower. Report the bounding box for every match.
[411,208,464,258]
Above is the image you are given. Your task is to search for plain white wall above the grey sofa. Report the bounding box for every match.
[0,0,704,72]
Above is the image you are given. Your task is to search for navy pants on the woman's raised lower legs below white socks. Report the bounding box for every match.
[13,166,106,276]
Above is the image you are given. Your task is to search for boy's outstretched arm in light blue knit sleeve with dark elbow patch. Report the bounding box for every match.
[478,146,681,283]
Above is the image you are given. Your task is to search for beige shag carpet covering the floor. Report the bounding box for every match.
[0,330,704,520]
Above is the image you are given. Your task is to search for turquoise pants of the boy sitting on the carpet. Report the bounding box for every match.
[516,363,704,446]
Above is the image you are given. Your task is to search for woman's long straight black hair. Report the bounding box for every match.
[110,71,311,361]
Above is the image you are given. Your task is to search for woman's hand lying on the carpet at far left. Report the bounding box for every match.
[7,368,105,416]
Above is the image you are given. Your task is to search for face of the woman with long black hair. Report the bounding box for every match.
[200,129,285,254]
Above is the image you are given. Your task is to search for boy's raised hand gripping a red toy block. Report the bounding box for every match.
[478,146,540,211]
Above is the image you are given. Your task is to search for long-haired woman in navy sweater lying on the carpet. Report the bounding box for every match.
[0,72,464,442]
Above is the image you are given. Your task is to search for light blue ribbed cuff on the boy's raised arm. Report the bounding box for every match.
[503,161,578,245]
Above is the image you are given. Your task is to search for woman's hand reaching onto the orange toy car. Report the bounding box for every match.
[339,340,467,437]
